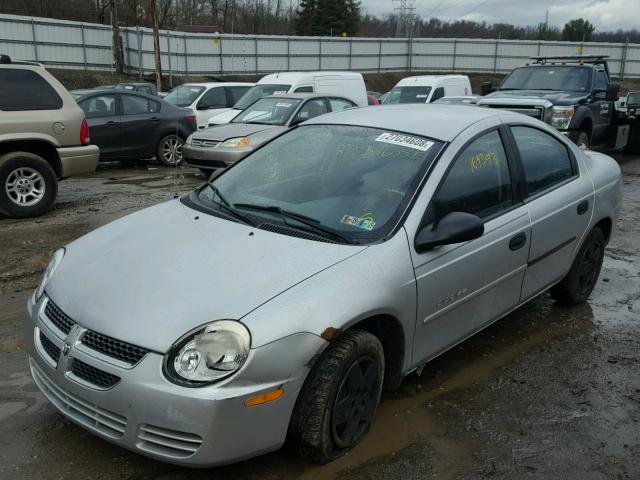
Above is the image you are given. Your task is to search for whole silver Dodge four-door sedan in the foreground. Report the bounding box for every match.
[25,105,622,467]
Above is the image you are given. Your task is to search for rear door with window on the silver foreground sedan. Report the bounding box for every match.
[509,125,594,300]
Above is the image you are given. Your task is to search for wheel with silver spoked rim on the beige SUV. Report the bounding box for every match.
[0,152,58,218]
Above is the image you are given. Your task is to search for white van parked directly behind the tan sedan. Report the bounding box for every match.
[209,71,368,127]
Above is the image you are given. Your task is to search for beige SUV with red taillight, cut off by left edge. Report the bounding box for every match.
[0,55,98,217]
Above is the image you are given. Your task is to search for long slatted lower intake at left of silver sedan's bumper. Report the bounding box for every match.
[29,359,127,438]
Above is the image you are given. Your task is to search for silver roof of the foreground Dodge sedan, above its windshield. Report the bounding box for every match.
[304,103,521,141]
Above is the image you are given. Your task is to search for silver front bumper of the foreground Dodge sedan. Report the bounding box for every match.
[24,296,326,467]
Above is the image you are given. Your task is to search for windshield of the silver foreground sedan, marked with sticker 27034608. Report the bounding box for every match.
[191,125,443,243]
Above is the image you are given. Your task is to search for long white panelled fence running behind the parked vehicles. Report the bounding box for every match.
[0,14,640,78]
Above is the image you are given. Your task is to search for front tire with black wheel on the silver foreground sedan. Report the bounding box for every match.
[288,330,384,464]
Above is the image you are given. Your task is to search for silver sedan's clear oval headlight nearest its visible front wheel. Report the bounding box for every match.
[165,320,251,386]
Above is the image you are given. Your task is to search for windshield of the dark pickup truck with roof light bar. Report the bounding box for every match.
[499,65,591,92]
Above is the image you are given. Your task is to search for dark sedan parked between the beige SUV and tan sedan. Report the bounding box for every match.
[72,89,196,166]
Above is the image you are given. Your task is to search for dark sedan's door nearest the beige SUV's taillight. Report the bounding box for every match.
[79,93,122,159]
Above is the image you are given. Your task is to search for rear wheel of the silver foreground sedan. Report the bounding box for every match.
[550,228,605,305]
